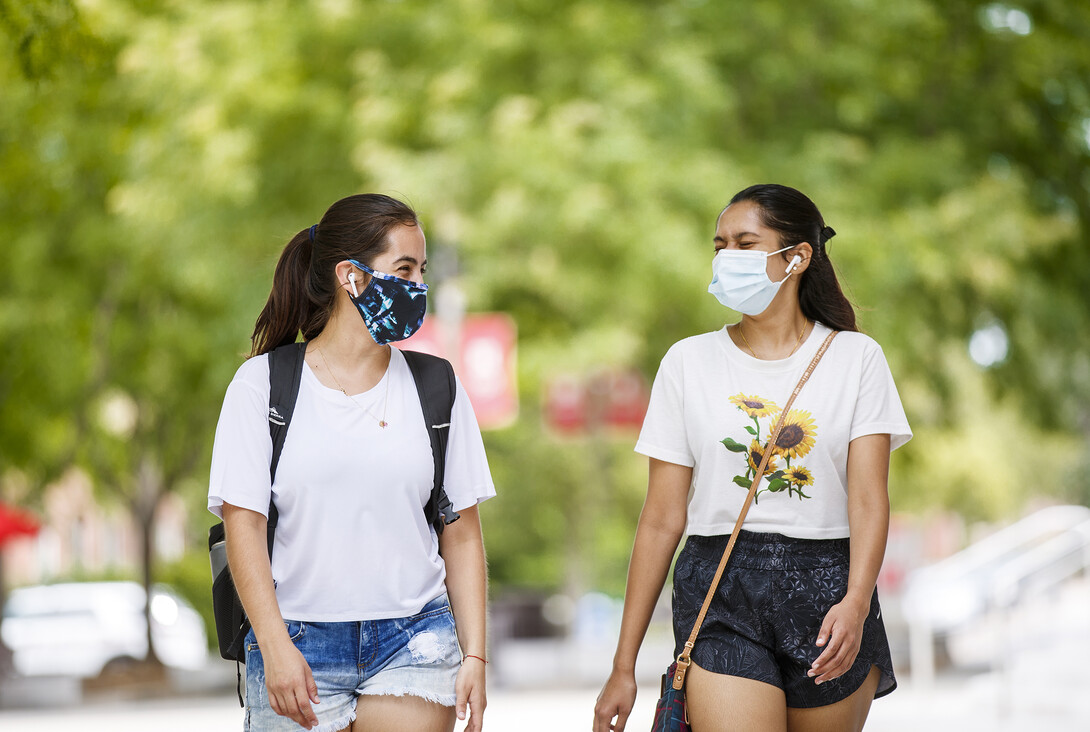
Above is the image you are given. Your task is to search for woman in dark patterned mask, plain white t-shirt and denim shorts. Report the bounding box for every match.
[208,194,495,732]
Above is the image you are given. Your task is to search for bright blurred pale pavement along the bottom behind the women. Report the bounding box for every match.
[0,581,1090,732]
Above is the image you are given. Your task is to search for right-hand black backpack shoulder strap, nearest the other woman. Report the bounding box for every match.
[401,351,460,534]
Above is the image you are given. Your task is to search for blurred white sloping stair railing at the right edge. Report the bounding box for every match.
[901,505,1090,684]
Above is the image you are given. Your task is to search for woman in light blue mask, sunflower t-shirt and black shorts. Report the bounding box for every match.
[592,184,911,732]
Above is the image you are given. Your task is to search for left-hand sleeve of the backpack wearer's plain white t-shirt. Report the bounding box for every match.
[208,358,273,519]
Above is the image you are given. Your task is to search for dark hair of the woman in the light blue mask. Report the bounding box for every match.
[730,183,859,330]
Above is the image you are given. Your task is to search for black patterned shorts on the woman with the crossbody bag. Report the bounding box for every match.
[674,532,897,708]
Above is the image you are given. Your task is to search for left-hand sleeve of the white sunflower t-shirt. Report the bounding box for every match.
[635,347,697,467]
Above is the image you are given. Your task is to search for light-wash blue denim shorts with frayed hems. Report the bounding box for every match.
[245,594,461,732]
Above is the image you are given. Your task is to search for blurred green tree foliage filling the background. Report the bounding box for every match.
[0,0,1090,589]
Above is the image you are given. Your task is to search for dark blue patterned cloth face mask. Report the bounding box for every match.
[349,259,427,345]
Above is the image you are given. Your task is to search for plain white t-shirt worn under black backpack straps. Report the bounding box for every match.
[208,349,496,622]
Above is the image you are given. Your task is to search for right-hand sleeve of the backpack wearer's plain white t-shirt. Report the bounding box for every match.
[444,379,496,511]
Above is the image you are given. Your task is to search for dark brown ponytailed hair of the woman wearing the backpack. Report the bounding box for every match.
[250,193,420,356]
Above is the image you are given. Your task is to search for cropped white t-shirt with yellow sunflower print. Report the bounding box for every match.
[635,324,912,539]
